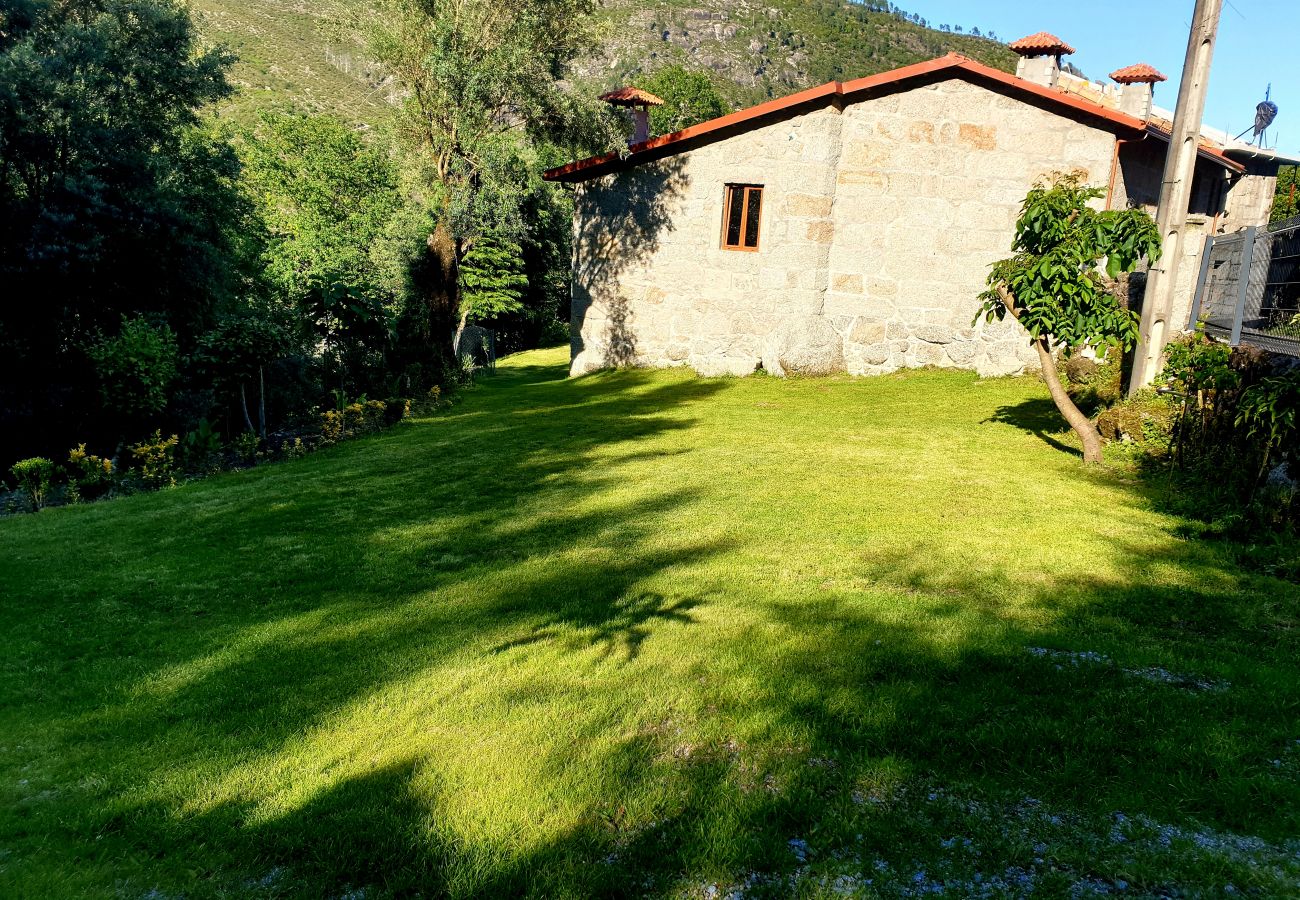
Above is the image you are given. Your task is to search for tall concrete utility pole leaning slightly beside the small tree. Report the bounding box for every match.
[1128,0,1223,394]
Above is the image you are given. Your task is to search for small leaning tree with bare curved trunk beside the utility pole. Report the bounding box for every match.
[975,173,1161,463]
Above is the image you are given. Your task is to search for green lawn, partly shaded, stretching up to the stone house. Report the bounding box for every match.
[0,351,1300,897]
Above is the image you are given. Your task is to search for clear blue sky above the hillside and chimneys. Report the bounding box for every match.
[898,0,1300,152]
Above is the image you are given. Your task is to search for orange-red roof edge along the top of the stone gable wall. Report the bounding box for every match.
[542,53,1147,182]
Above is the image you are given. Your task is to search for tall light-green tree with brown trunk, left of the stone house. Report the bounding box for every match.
[358,0,618,364]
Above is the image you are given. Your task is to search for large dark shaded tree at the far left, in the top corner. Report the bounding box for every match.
[0,0,247,453]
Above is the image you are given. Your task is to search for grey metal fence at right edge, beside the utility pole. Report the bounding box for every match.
[1190,218,1300,356]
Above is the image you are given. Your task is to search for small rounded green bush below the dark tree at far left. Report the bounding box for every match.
[86,316,177,419]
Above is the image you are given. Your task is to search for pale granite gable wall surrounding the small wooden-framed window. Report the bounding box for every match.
[572,72,1114,375]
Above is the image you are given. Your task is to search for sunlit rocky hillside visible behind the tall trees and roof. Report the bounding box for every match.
[192,0,1015,121]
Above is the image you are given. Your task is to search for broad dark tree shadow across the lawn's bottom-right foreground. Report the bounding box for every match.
[152,528,1300,897]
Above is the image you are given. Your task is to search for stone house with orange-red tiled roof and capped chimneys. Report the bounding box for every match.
[546,34,1288,375]
